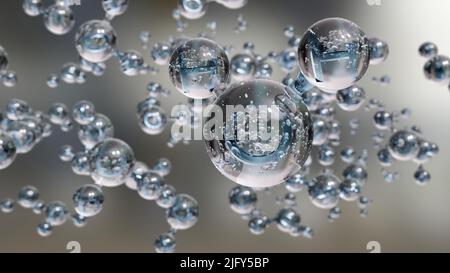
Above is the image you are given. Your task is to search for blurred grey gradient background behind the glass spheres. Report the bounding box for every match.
[0,0,450,252]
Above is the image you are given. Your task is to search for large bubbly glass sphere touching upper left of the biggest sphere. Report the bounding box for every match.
[169,38,230,99]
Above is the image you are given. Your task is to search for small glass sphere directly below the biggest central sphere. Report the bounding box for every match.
[228,186,258,215]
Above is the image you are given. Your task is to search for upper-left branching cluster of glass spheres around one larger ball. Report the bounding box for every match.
[47,0,157,88]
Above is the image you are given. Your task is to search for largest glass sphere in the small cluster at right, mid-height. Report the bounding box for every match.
[389,131,419,161]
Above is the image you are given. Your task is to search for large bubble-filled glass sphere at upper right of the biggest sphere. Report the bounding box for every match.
[298,18,370,93]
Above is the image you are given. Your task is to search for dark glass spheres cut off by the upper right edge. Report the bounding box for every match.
[419,42,450,90]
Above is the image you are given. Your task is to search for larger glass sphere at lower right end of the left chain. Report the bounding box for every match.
[166,194,199,230]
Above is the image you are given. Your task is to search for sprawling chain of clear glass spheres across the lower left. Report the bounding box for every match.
[0,99,199,253]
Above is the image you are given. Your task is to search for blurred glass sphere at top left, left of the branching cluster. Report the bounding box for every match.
[44,5,75,35]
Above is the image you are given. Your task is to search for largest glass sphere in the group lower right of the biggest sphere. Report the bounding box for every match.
[309,174,341,209]
